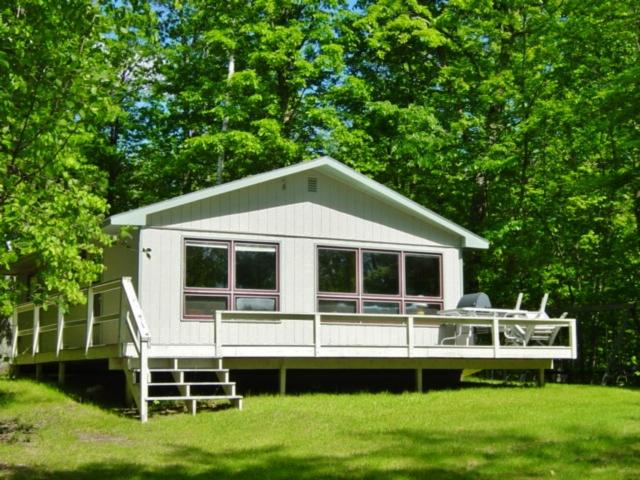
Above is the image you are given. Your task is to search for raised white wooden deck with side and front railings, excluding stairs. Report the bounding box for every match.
[12,294,577,364]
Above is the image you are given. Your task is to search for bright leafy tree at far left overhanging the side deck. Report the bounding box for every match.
[0,0,115,313]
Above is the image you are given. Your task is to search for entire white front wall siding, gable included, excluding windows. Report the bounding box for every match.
[130,172,470,345]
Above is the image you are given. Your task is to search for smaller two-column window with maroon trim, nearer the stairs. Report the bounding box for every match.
[182,240,280,320]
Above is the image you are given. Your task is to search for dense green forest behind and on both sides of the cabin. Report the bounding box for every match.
[0,0,640,383]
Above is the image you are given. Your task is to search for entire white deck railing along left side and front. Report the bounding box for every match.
[12,286,577,366]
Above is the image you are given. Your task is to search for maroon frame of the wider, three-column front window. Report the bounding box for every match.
[315,244,444,315]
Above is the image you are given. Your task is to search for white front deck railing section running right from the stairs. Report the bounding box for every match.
[214,311,577,359]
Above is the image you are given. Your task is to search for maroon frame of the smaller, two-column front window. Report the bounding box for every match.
[180,237,280,322]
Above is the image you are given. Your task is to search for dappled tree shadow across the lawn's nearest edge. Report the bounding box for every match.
[5,429,640,480]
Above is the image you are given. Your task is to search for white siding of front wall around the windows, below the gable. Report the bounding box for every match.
[140,229,462,345]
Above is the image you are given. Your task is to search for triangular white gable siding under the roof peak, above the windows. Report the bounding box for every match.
[150,173,460,247]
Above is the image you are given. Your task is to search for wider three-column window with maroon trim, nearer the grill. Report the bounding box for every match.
[317,247,442,315]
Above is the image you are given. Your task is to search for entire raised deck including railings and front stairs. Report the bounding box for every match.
[11,277,577,421]
